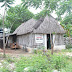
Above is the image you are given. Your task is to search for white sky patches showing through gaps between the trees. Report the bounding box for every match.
[0,0,57,18]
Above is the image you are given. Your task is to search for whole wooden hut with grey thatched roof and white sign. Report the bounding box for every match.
[9,16,65,50]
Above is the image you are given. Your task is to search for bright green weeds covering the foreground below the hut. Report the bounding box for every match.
[15,53,72,72]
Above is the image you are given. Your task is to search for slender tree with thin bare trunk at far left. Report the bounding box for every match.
[0,0,14,57]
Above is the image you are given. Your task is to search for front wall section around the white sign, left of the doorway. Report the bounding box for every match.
[30,34,47,49]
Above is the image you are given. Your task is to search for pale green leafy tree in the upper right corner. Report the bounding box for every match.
[56,0,72,17]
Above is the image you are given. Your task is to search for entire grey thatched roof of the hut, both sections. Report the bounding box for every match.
[13,16,65,35]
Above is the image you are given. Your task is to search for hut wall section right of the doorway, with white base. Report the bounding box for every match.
[53,34,66,50]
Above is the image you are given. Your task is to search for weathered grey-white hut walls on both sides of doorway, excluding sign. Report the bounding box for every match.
[12,33,65,50]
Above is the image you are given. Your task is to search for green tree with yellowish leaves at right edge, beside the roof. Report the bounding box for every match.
[61,14,72,37]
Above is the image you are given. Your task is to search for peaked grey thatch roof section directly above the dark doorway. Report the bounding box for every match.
[33,16,65,34]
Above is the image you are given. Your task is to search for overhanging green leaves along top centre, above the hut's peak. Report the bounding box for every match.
[22,0,60,13]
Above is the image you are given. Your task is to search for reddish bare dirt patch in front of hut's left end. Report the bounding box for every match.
[0,48,32,57]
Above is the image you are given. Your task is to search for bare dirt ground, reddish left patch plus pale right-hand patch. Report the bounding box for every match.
[0,48,72,57]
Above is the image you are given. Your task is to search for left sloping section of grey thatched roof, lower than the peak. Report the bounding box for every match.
[13,18,36,35]
